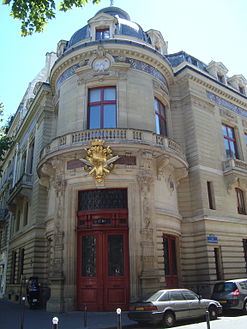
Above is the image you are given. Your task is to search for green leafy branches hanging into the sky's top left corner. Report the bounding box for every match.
[3,0,101,36]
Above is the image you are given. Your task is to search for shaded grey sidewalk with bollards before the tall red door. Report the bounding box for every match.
[0,299,138,329]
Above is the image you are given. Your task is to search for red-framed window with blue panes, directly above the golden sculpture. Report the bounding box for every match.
[88,87,117,129]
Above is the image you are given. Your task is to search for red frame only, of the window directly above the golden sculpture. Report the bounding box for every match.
[87,86,117,129]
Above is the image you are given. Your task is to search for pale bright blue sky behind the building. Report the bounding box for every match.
[0,0,247,119]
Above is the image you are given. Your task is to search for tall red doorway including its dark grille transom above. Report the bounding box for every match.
[77,189,129,311]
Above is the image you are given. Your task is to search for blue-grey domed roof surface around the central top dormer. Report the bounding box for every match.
[67,7,151,49]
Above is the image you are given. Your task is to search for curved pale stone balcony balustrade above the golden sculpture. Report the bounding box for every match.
[40,128,186,161]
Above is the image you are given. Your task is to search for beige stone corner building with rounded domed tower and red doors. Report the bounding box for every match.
[0,7,247,311]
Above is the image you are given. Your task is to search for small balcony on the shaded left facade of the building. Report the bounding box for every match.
[8,174,32,205]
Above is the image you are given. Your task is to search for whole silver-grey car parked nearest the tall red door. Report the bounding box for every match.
[128,289,222,328]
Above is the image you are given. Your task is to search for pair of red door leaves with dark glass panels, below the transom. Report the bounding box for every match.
[77,230,129,311]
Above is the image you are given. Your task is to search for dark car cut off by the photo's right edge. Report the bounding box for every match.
[211,279,247,314]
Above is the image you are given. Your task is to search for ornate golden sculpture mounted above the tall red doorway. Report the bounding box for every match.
[80,139,119,183]
